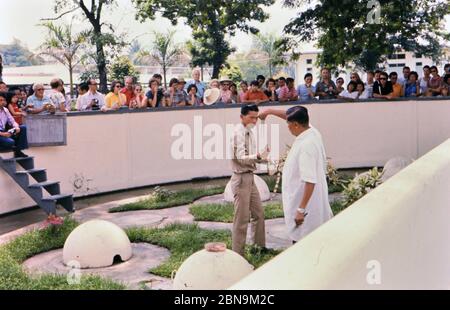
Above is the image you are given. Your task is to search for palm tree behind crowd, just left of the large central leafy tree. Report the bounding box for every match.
[138,30,183,88]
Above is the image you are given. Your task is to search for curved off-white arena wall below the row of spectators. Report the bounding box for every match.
[0,100,450,214]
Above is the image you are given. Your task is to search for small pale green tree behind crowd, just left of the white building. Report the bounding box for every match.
[253,33,286,77]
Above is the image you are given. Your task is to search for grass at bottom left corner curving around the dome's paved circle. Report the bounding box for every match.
[0,219,125,290]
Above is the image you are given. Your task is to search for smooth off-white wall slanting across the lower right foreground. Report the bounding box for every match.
[232,139,450,290]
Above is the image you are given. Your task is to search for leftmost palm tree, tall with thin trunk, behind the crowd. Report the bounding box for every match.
[40,22,89,96]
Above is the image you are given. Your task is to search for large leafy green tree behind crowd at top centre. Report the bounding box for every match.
[133,0,275,78]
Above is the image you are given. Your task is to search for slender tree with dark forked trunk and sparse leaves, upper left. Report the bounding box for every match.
[48,0,125,92]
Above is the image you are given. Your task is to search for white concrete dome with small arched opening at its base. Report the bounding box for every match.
[63,220,131,269]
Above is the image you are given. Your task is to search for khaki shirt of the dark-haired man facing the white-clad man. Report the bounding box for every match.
[231,124,261,174]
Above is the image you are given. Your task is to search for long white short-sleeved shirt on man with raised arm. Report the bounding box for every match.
[282,127,333,241]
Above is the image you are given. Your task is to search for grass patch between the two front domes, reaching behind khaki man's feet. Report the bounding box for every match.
[127,224,280,278]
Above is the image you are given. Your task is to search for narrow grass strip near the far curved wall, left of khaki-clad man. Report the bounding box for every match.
[109,186,225,213]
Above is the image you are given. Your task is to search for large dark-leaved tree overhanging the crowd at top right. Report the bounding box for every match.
[283,0,450,70]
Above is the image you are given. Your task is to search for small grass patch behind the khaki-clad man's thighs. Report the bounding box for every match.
[190,203,284,223]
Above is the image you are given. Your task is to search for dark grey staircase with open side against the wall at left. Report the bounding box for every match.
[0,156,74,214]
